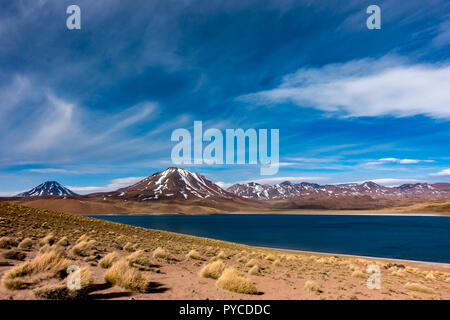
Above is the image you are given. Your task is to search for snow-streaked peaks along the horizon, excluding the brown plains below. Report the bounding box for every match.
[17,167,450,201]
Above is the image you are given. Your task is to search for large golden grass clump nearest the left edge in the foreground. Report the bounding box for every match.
[2,251,70,290]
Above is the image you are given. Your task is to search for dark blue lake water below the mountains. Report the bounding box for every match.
[92,214,450,263]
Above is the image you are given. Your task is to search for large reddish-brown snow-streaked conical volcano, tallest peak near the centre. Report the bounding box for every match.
[110,167,239,201]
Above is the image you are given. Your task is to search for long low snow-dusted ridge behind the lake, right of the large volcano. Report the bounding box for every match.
[227,181,450,200]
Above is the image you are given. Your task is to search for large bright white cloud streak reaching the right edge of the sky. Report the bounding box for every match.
[238,57,450,119]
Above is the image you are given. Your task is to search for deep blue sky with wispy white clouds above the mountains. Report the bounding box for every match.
[0,0,450,195]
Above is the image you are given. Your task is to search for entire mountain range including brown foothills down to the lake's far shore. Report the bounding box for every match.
[8,167,450,214]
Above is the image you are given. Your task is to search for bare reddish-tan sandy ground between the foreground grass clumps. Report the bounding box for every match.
[0,242,450,300]
